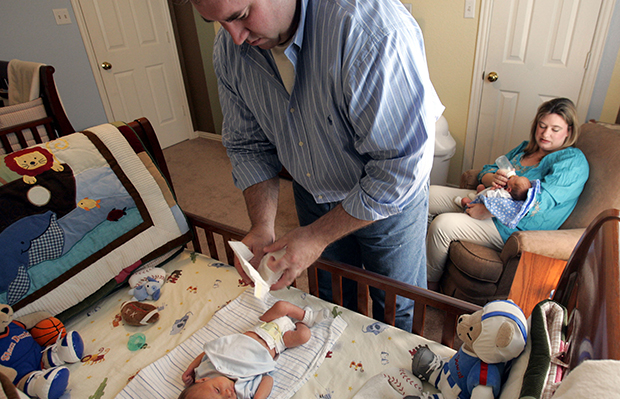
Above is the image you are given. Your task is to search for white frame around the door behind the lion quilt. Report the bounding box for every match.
[71,0,198,139]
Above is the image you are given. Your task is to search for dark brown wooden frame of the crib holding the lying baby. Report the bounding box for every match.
[0,111,620,370]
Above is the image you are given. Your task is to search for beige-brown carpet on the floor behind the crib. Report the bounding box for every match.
[164,138,456,340]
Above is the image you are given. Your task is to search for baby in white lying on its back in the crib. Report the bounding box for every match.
[179,301,331,399]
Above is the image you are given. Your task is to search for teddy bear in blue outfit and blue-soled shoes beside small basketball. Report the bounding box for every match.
[0,304,84,399]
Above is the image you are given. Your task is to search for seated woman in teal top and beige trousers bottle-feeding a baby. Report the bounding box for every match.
[426,98,590,289]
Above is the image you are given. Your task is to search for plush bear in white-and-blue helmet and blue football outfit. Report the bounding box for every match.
[412,301,527,399]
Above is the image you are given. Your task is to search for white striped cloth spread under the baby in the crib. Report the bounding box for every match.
[117,288,347,399]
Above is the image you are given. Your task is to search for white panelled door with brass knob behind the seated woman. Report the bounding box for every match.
[473,0,602,168]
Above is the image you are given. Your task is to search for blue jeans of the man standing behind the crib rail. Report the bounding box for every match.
[293,182,428,331]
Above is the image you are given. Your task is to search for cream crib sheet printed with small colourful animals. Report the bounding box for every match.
[65,250,454,398]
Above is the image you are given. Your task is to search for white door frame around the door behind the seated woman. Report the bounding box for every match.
[461,0,616,172]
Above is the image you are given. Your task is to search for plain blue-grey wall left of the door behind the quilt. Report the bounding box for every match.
[0,0,107,131]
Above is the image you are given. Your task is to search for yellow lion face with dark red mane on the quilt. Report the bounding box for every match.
[4,147,64,184]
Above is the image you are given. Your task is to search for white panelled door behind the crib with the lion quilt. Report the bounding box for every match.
[76,0,193,148]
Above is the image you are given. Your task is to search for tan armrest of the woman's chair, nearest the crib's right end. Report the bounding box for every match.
[500,229,585,264]
